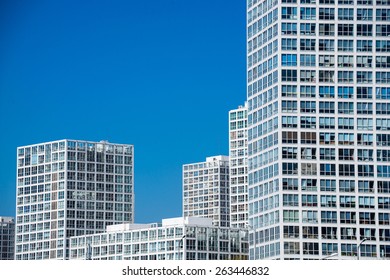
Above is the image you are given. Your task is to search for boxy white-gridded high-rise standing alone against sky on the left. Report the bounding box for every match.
[15,140,134,260]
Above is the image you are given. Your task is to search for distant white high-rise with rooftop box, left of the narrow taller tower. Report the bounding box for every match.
[183,156,230,227]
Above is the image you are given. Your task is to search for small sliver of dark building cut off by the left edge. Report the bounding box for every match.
[0,217,15,260]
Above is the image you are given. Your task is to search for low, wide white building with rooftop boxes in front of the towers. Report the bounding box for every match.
[70,217,248,260]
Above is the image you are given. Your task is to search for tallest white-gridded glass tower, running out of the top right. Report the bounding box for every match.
[247,0,390,259]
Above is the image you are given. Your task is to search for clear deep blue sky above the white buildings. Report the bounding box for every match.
[0,0,246,223]
